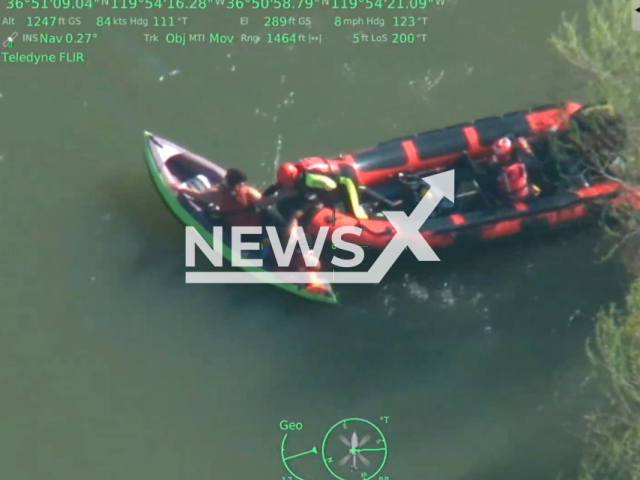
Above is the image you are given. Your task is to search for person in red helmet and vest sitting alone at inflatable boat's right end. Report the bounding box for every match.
[490,137,539,200]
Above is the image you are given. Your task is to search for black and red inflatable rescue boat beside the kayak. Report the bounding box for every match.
[296,103,640,250]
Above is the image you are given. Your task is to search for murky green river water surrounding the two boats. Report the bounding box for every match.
[0,0,625,480]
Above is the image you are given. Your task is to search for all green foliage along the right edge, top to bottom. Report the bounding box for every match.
[552,0,640,480]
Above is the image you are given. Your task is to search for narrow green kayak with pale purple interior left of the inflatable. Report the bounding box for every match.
[144,132,338,304]
